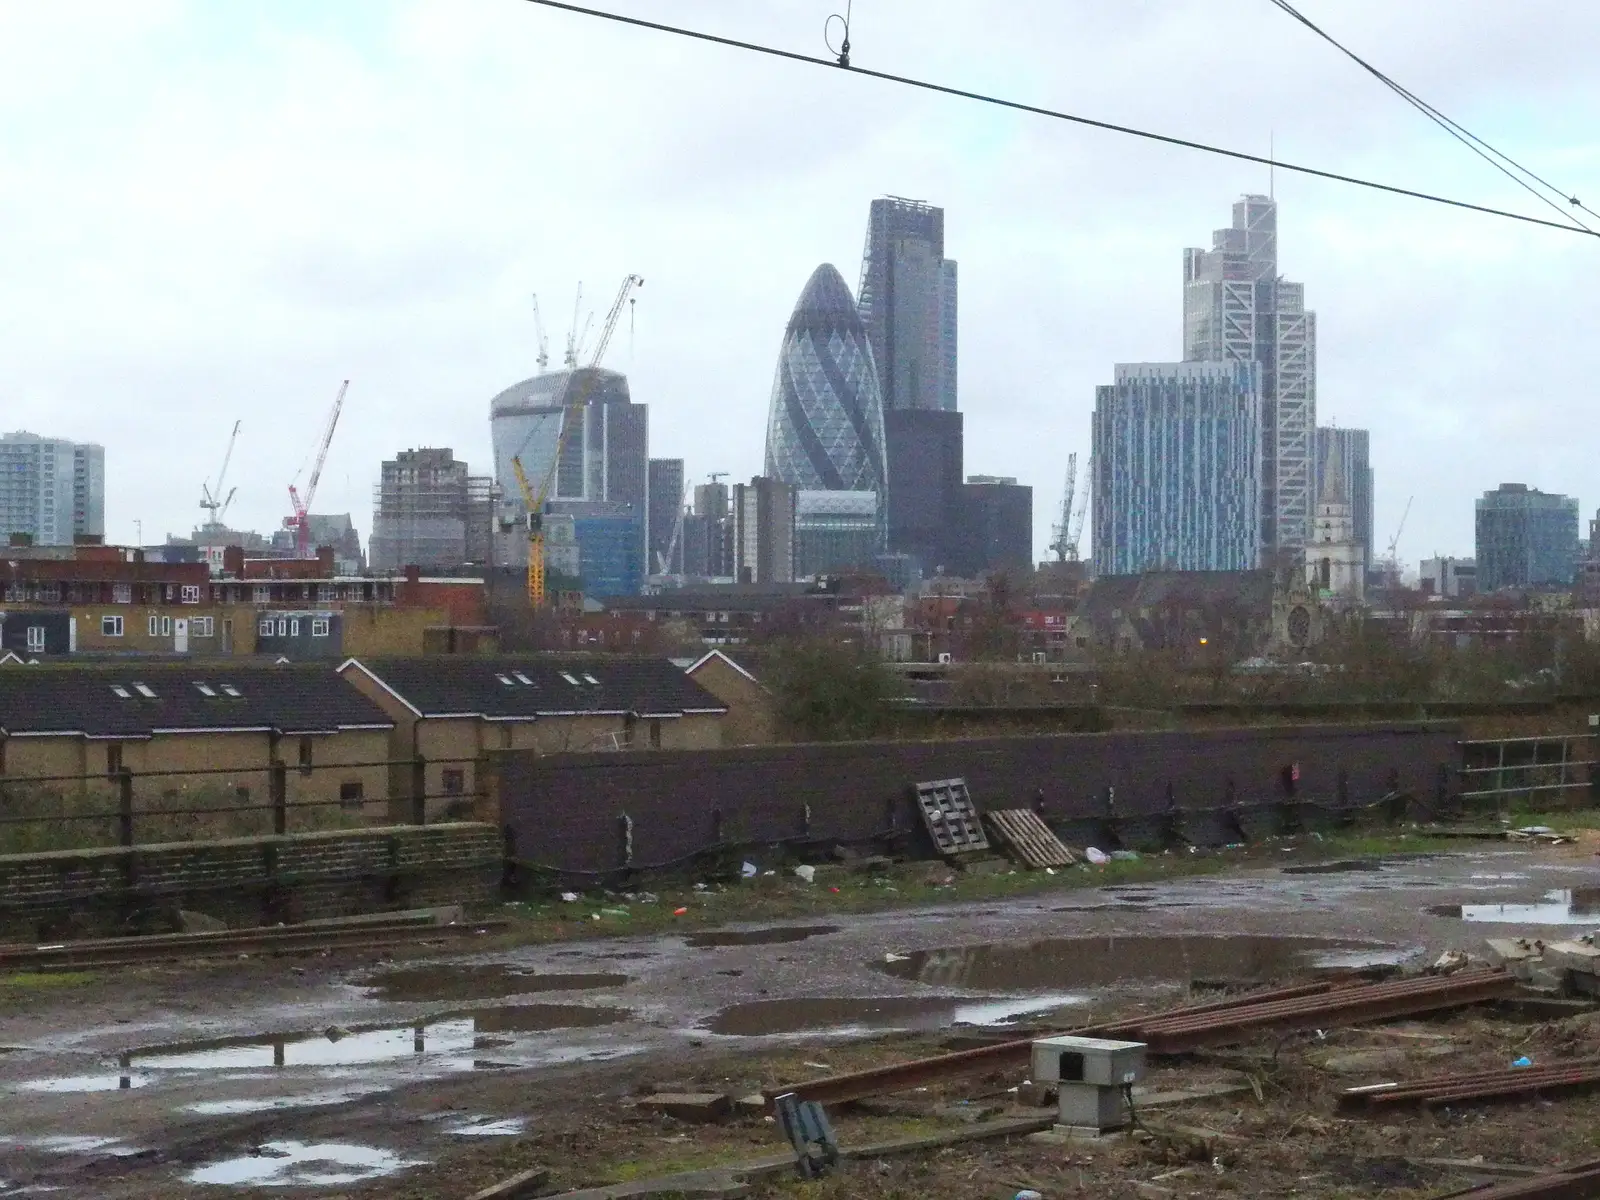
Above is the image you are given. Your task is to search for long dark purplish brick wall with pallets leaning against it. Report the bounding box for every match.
[496,722,1461,878]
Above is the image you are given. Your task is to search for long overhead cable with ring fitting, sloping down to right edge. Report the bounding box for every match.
[526,0,1600,237]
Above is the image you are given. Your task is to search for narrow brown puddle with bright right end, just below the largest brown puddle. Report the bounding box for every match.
[702,994,1088,1037]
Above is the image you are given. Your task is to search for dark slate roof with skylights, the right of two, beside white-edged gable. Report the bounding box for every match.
[339,654,728,720]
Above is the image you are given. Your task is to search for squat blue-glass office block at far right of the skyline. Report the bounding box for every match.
[1475,483,1578,592]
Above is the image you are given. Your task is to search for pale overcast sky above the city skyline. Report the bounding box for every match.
[0,0,1600,570]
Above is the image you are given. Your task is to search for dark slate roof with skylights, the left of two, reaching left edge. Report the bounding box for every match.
[0,661,394,739]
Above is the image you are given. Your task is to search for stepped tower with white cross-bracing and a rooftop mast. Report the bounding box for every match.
[1184,195,1317,560]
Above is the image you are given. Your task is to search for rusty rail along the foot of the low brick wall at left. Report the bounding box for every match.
[0,920,507,971]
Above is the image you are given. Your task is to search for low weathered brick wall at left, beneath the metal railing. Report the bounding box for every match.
[0,822,502,939]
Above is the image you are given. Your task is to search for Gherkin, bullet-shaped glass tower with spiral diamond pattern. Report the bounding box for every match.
[766,262,888,525]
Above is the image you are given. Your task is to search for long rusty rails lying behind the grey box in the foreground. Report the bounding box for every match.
[766,968,1517,1104]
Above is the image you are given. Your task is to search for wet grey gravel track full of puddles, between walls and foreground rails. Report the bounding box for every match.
[0,851,1600,1197]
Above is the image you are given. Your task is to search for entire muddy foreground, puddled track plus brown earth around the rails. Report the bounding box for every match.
[0,846,1600,1200]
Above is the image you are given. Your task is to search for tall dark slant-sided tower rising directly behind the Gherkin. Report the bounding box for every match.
[861,197,957,413]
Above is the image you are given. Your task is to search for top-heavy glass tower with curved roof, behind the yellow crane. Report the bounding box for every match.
[490,366,650,588]
